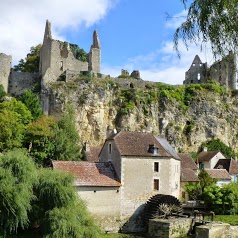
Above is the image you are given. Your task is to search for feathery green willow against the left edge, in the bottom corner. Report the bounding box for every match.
[0,149,36,234]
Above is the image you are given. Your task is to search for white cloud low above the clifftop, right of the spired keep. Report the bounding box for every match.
[102,41,213,85]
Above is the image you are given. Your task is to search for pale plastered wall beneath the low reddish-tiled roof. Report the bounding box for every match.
[76,186,120,232]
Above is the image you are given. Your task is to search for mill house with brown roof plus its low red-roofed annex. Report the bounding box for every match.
[53,131,180,232]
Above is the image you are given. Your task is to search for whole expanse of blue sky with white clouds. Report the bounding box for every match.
[0,0,212,84]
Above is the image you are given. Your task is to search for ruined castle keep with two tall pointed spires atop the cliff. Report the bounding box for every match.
[39,21,101,114]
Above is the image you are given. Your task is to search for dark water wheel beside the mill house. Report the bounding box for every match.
[144,194,183,225]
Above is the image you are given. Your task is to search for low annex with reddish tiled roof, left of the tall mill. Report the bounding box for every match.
[52,161,121,231]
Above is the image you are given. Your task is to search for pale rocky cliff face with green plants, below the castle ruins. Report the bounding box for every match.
[47,79,238,151]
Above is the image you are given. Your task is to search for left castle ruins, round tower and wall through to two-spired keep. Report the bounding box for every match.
[0,20,101,104]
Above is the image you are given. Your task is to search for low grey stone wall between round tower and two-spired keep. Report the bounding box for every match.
[8,70,39,96]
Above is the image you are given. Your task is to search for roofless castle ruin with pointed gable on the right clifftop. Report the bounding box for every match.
[183,52,237,90]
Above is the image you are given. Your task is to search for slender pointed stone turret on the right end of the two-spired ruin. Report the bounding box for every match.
[88,31,101,73]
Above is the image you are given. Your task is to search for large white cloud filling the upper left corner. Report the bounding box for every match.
[0,0,116,63]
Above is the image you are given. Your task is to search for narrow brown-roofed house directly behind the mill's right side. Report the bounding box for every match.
[178,153,199,201]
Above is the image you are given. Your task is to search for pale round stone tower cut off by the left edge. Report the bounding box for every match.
[0,53,12,92]
